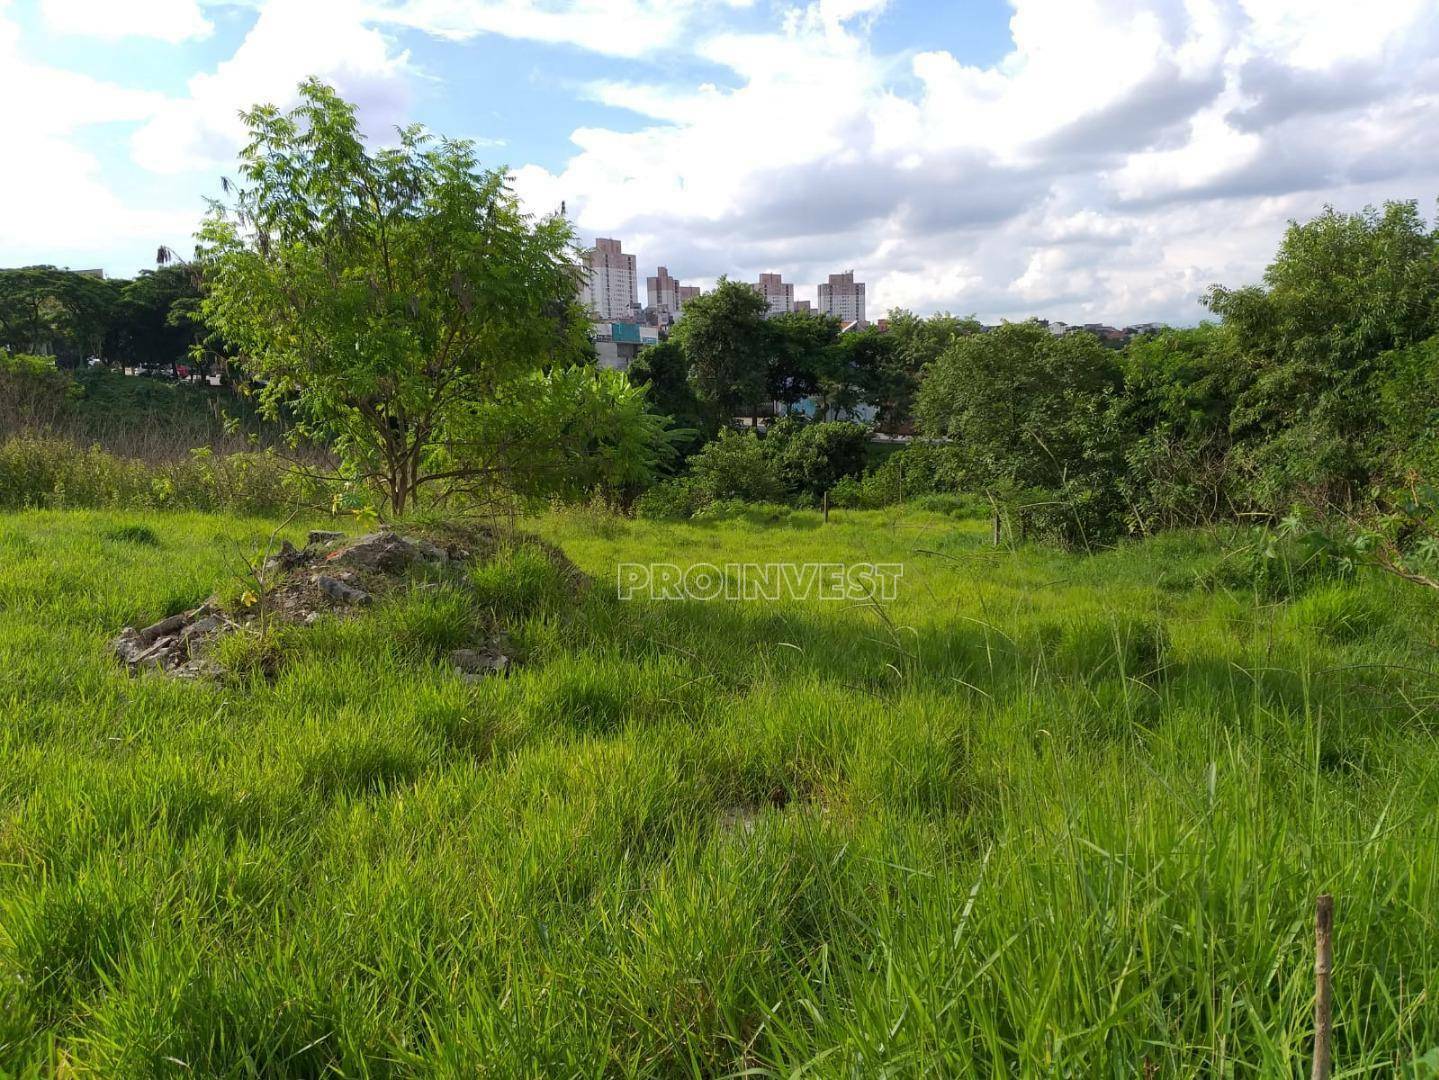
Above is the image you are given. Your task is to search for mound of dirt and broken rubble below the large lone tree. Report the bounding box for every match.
[111,526,566,679]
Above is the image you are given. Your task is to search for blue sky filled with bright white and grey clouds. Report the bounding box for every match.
[0,0,1439,324]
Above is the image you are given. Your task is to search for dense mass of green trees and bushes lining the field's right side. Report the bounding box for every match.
[917,203,1439,542]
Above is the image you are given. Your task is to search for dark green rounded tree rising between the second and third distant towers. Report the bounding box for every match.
[671,278,773,423]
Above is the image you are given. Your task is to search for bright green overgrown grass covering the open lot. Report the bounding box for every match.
[0,511,1439,1077]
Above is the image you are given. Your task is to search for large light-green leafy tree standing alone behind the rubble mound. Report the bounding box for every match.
[199,81,586,513]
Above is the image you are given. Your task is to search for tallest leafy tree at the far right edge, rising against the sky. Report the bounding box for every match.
[1206,203,1439,506]
